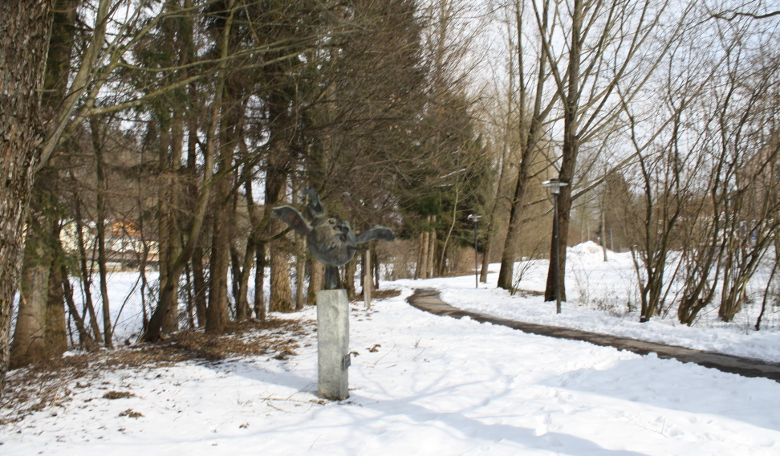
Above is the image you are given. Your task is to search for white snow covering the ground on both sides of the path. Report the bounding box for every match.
[0,246,780,456]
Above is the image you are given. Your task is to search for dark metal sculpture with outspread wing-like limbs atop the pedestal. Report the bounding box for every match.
[271,189,395,266]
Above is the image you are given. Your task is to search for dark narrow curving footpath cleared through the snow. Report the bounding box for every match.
[407,288,780,382]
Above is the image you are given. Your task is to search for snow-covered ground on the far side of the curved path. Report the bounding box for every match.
[418,242,780,363]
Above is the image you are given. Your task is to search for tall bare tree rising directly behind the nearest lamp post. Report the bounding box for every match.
[534,0,690,300]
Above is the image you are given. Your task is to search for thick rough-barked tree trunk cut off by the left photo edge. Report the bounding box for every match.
[0,0,52,394]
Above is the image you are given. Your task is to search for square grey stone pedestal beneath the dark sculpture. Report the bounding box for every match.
[317,290,350,401]
